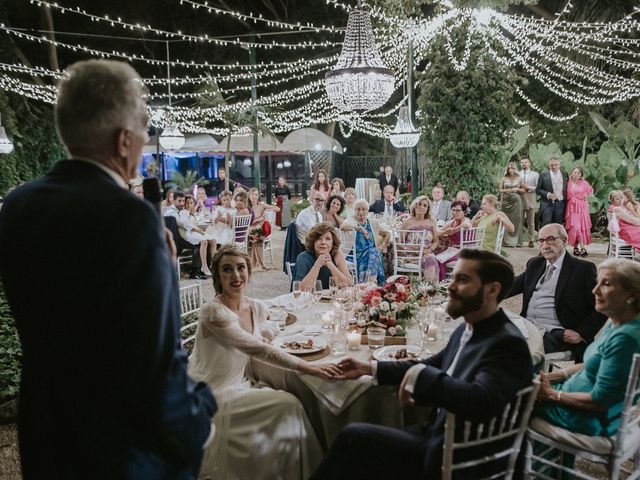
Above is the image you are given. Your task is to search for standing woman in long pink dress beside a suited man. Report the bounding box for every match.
[564,167,593,257]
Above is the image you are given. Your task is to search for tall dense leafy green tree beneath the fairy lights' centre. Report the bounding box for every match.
[418,26,517,198]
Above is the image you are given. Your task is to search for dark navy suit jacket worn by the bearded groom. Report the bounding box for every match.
[377,310,533,478]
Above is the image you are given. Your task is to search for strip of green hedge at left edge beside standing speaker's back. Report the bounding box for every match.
[0,284,22,421]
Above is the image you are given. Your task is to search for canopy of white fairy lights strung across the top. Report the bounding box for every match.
[0,0,640,137]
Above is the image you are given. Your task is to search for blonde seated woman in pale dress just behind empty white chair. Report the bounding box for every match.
[400,195,440,284]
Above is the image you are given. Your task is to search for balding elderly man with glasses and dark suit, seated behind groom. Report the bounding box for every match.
[509,223,606,362]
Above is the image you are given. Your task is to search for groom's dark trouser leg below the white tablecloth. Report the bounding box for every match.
[311,423,425,480]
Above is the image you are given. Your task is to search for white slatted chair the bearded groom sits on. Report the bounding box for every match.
[442,381,540,480]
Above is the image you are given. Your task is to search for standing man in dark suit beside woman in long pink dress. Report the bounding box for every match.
[536,157,569,226]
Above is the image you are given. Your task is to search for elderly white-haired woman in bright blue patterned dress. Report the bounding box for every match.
[341,198,391,284]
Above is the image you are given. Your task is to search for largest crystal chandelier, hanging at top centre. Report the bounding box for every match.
[325,0,395,111]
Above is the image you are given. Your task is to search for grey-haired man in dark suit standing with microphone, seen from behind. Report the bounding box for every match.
[0,60,216,479]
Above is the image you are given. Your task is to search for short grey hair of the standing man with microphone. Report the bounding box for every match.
[54,60,147,156]
